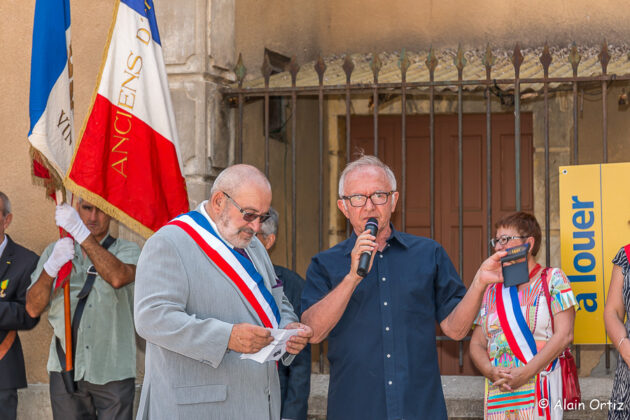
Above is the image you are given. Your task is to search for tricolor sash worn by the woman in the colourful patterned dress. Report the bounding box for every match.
[494,269,558,419]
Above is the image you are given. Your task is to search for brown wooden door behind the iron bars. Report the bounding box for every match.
[351,114,533,375]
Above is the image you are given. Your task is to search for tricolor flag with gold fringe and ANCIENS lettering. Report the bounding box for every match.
[65,0,189,237]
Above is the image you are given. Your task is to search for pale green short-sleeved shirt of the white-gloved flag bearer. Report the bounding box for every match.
[31,238,140,385]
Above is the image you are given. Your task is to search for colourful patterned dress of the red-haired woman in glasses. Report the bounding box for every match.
[475,265,577,420]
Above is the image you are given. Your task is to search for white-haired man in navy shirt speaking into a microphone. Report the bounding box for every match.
[302,156,505,420]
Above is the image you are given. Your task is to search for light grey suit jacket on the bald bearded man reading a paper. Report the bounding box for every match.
[134,210,297,420]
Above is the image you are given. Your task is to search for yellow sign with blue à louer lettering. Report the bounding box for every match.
[559,163,630,344]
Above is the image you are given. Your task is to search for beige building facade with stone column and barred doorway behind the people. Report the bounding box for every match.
[0,0,630,394]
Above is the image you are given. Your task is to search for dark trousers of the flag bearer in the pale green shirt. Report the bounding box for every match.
[50,372,135,420]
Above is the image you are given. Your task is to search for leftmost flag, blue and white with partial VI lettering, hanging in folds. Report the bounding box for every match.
[28,0,75,195]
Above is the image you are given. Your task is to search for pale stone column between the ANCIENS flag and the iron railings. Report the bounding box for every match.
[155,0,235,208]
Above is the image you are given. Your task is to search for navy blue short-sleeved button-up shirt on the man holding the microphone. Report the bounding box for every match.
[302,228,466,420]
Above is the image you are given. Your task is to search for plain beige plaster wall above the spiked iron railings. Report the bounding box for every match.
[235,0,630,79]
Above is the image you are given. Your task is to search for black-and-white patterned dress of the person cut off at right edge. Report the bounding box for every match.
[608,248,630,420]
